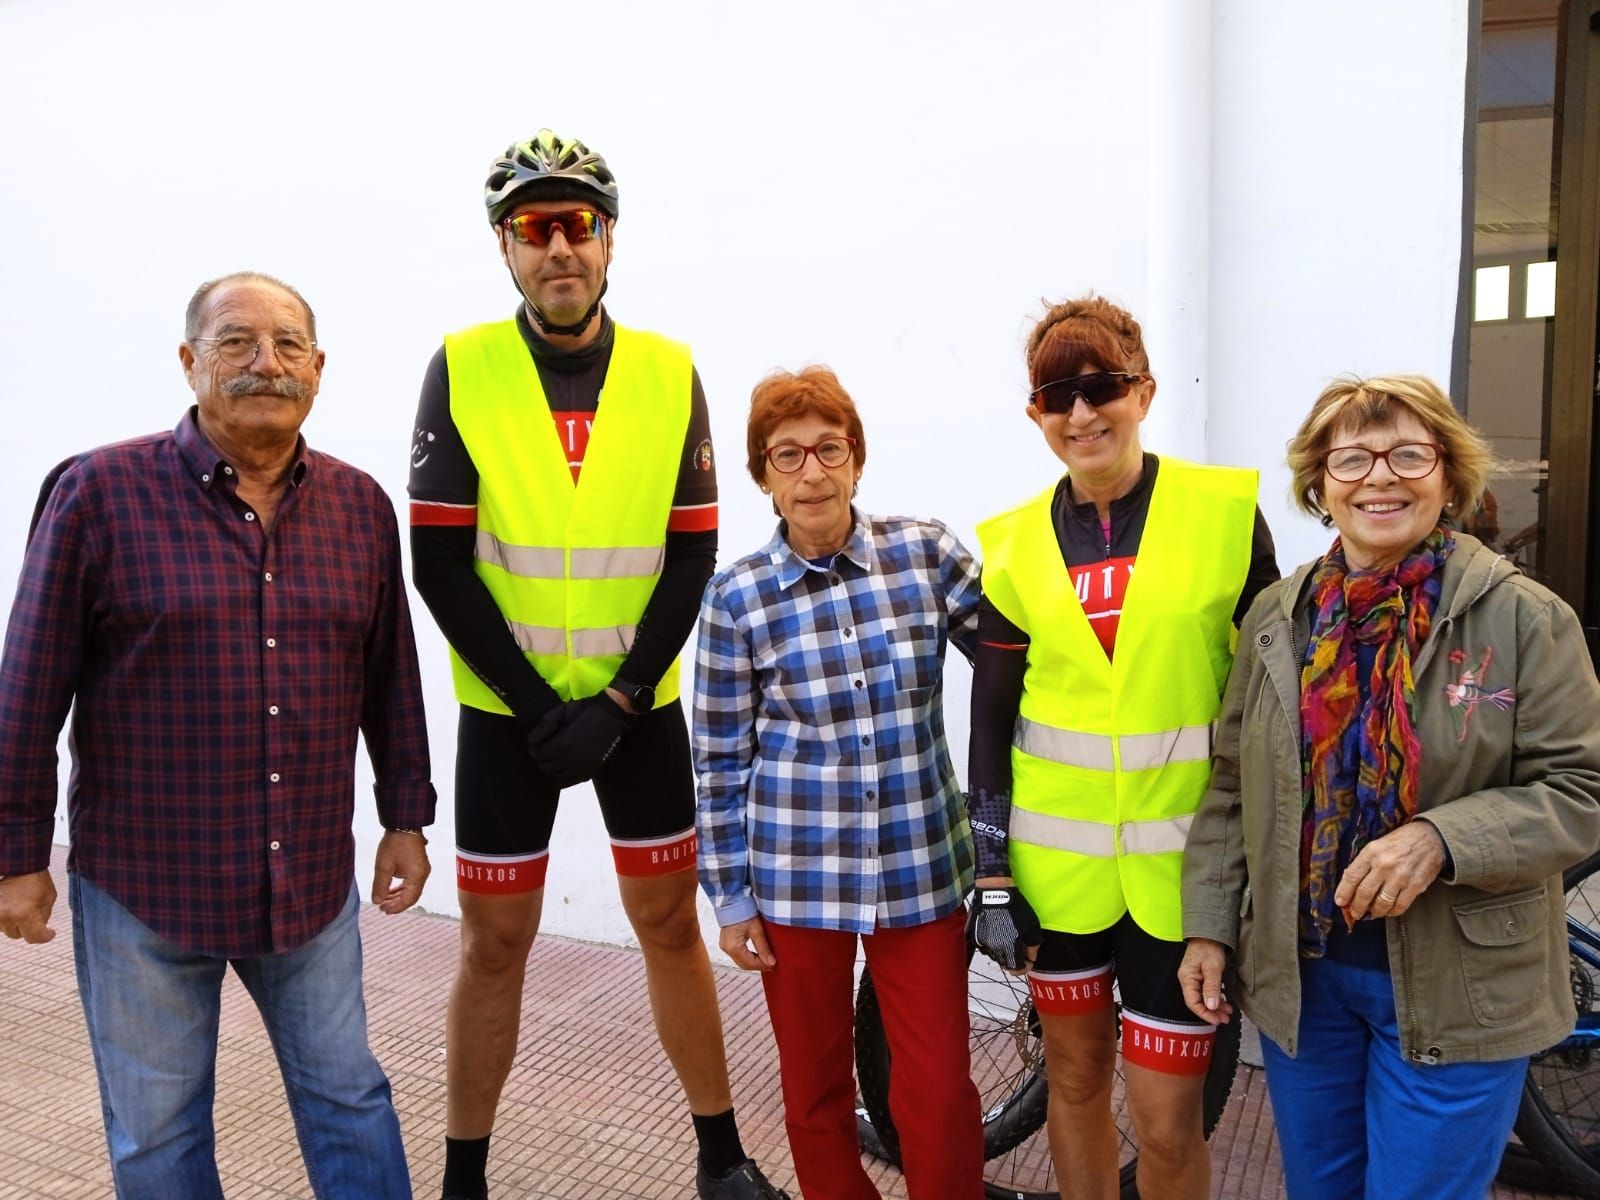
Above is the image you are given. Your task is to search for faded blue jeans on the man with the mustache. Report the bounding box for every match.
[69,874,411,1200]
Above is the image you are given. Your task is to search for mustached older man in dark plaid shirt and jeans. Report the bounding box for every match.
[0,272,435,1200]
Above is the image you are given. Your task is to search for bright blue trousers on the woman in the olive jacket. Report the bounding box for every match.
[1261,958,1528,1200]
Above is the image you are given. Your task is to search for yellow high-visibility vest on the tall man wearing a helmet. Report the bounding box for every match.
[445,320,693,714]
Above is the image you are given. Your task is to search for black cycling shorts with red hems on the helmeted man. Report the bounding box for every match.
[456,702,694,894]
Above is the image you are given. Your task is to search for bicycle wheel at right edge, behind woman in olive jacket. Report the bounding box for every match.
[1517,854,1600,1197]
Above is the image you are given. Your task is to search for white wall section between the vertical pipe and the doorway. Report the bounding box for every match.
[1206,0,1472,570]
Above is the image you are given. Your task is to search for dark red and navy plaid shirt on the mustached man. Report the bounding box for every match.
[0,410,434,957]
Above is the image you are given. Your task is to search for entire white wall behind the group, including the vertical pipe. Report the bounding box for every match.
[0,0,1466,941]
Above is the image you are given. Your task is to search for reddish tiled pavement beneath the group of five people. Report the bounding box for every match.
[0,851,1574,1200]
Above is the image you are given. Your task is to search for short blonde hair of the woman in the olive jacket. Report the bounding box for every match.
[1288,374,1494,520]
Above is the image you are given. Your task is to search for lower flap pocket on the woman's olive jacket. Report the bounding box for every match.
[1453,885,1549,1026]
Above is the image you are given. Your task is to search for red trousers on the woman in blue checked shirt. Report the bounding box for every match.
[762,909,984,1200]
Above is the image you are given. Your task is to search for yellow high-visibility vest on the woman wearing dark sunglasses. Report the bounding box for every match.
[978,458,1256,941]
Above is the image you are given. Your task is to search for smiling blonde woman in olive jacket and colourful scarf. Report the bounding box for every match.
[1179,376,1600,1200]
